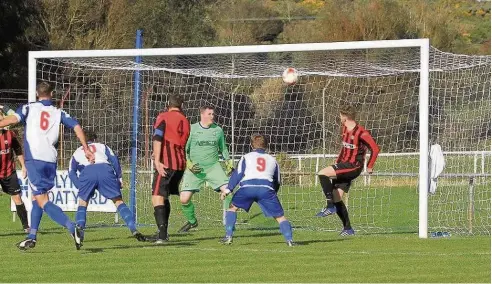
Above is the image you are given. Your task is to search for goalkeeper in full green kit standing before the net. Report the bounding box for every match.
[178,106,234,233]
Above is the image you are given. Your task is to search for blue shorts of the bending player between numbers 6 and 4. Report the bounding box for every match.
[79,164,121,202]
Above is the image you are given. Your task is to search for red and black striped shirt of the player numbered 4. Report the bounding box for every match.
[153,111,190,170]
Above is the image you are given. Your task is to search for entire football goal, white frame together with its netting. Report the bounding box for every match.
[29,39,491,237]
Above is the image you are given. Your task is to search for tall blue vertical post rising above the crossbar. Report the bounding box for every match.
[129,30,142,224]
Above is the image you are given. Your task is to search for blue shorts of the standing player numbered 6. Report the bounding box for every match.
[26,160,56,195]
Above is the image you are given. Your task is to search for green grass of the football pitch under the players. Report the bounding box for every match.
[0,186,491,283]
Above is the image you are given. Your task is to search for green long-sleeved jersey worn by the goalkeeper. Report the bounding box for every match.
[186,122,230,168]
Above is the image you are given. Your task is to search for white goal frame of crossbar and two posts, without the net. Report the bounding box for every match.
[28,39,430,238]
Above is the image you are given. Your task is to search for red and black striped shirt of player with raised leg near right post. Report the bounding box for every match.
[337,124,379,168]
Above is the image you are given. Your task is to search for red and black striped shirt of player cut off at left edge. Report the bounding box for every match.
[0,129,22,179]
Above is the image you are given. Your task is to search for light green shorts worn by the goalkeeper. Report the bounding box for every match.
[181,163,229,192]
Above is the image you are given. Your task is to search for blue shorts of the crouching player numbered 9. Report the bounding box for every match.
[231,187,284,217]
